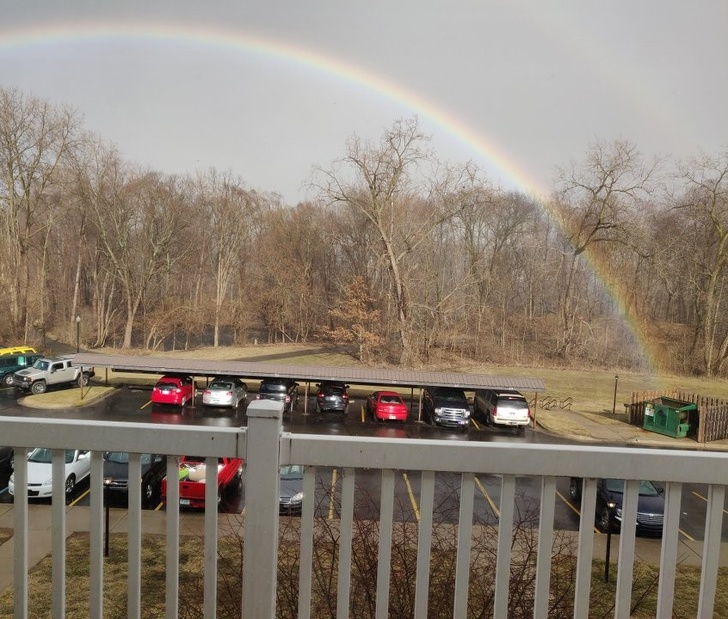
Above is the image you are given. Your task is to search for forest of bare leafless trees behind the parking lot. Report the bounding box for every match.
[0,89,728,377]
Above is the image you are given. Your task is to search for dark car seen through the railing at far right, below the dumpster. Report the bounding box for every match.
[569,477,665,535]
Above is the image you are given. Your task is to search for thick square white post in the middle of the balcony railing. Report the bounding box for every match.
[243,400,283,619]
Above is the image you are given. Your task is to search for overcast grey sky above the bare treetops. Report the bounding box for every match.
[0,0,728,203]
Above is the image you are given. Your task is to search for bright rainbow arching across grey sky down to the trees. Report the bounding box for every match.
[0,21,658,373]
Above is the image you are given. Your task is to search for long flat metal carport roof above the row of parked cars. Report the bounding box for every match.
[73,352,546,391]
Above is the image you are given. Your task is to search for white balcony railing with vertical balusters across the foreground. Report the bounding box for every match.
[0,401,728,619]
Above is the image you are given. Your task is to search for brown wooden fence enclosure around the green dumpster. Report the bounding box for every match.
[625,390,728,443]
